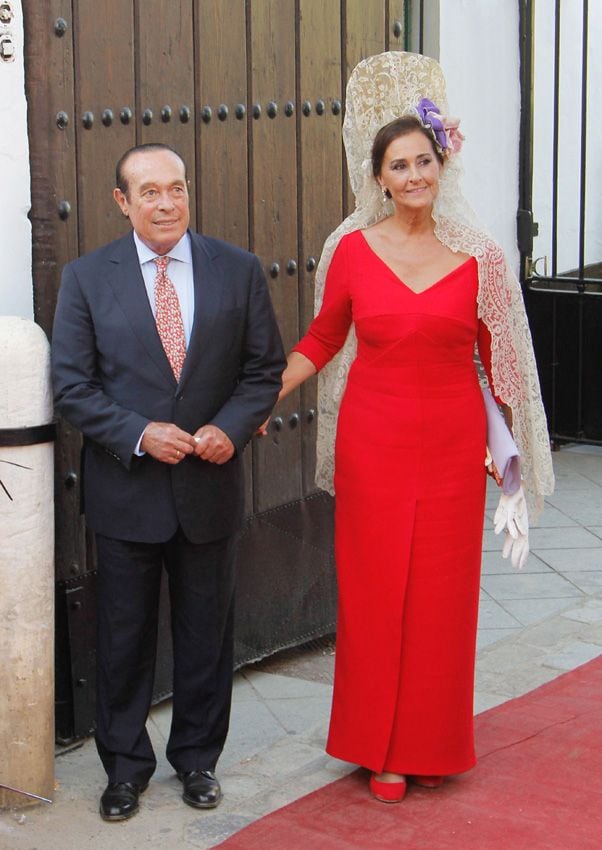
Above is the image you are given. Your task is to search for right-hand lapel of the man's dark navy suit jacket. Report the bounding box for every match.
[180,232,223,386]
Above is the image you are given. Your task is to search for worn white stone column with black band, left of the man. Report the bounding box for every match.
[0,316,54,807]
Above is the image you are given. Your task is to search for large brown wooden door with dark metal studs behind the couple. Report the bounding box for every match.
[23,0,406,739]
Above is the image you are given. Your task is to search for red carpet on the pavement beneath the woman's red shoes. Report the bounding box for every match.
[218,656,602,850]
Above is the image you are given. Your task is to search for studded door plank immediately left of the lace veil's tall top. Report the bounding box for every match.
[297,0,343,495]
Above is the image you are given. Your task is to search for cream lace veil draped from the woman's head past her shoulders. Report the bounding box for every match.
[315,52,554,516]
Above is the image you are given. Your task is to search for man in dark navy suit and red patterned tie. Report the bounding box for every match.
[52,144,285,820]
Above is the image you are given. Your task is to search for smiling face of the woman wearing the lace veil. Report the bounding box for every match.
[377,130,441,211]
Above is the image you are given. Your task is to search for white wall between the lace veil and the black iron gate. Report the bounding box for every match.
[436,0,520,270]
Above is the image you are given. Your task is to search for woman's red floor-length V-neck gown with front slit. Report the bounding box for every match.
[296,231,490,775]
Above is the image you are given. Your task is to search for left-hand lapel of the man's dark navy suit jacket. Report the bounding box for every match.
[109,233,176,387]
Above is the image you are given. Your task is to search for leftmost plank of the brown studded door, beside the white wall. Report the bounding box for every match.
[24,0,86,579]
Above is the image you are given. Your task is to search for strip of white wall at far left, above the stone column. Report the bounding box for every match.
[0,0,33,319]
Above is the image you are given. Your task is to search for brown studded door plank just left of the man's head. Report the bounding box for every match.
[74,0,136,254]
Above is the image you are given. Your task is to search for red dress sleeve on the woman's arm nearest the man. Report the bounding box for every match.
[293,238,352,371]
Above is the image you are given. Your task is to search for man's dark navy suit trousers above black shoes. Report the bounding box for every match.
[96,531,235,785]
